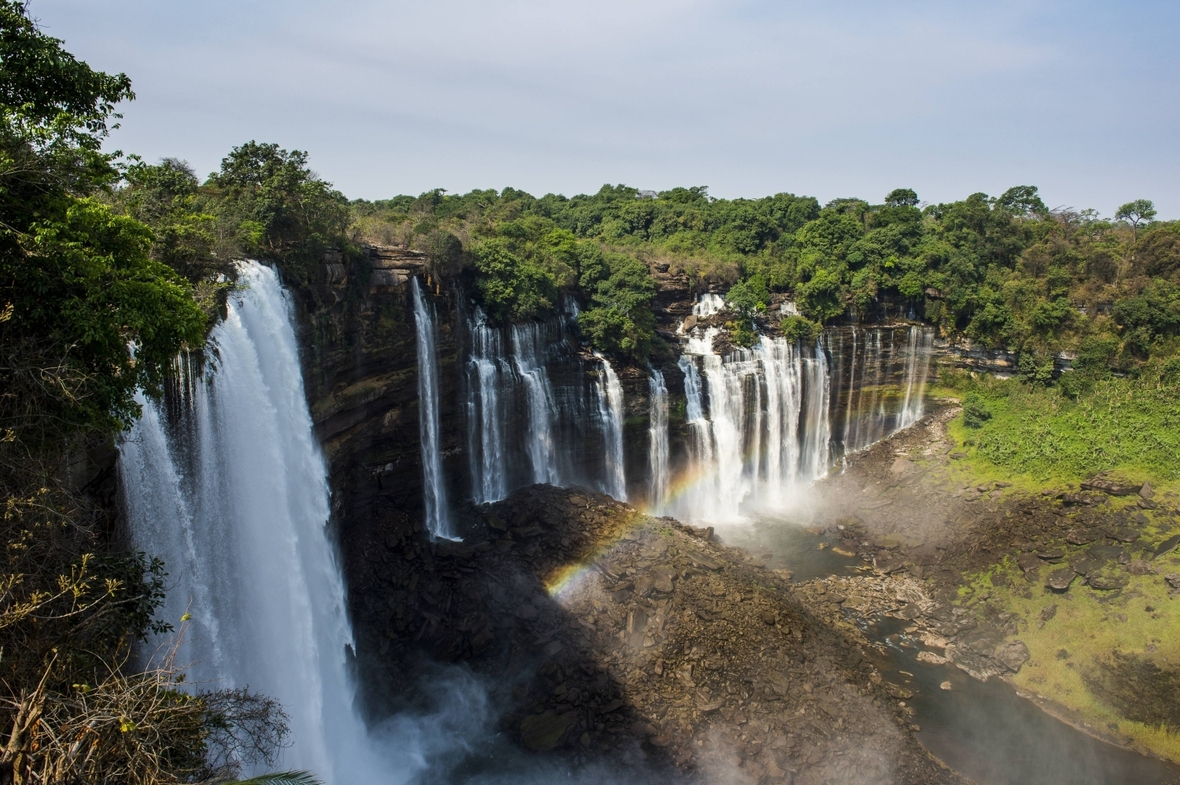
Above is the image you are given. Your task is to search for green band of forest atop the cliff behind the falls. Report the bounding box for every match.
[111,155,1180,371]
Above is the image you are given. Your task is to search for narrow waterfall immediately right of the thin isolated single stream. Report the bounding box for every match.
[466,308,509,504]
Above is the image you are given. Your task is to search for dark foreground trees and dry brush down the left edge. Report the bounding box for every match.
[0,0,295,784]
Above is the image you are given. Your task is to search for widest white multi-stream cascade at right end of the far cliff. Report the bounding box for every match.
[653,295,933,522]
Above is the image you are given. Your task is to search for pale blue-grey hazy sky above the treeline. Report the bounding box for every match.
[30,0,1180,218]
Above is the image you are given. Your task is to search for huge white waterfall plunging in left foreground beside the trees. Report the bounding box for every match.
[119,262,389,785]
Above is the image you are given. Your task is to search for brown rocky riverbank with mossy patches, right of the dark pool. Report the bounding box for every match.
[800,406,1180,757]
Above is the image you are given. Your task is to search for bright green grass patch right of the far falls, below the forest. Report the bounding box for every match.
[935,378,1180,484]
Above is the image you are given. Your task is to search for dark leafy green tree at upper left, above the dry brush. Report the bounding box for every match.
[0,0,205,444]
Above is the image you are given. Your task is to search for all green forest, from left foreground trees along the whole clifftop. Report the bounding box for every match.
[0,0,1180,783]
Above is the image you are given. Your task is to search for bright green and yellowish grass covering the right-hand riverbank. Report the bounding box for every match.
[935,374,1180,761]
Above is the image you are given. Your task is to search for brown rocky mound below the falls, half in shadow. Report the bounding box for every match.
[339,486,957,783]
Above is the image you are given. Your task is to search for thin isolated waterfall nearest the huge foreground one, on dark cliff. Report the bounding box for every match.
[409,277,458,539]
